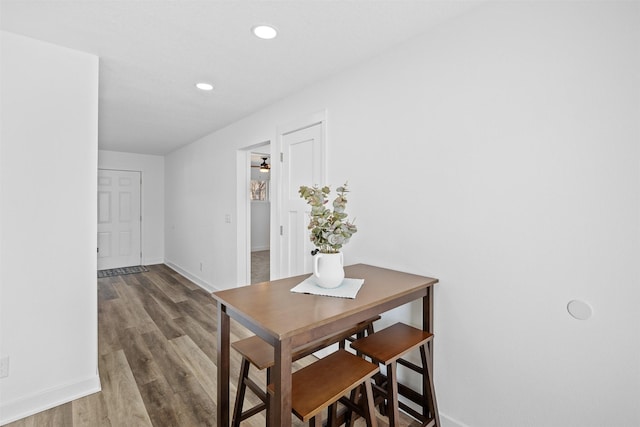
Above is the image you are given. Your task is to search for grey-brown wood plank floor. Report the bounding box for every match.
[7,265,419,427]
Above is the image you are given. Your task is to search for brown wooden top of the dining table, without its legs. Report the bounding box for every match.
[213,264,438,340]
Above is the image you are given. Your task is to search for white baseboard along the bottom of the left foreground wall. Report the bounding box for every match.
[0,374,102,425]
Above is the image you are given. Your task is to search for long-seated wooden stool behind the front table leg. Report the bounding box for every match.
[231,316,380,427]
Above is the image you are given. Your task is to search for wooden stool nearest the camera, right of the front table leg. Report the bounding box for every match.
[269,349,380,427]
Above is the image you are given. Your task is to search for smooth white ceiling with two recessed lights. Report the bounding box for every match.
[0,0,479,154]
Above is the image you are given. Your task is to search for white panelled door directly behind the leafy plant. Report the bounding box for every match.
[280,122,326,277]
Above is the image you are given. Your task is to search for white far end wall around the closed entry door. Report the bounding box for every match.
[98,150,164,265]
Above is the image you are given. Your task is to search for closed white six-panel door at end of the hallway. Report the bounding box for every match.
[98,169,142,270]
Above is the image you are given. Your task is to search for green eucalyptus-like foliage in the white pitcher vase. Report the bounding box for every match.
[298,183,358,254]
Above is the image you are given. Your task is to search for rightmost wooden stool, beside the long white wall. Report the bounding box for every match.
[351,323,440,427]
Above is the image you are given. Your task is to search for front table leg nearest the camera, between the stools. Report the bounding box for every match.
[271,339,291,427]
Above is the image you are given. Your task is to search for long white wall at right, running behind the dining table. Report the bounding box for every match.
[166,2,640,427]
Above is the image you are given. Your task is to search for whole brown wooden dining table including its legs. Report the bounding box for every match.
[213,264,438,427]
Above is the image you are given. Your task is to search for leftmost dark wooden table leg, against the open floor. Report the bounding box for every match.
[218,302,231,427]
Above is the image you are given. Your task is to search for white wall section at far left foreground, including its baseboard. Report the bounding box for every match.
[0,32,100,424]
